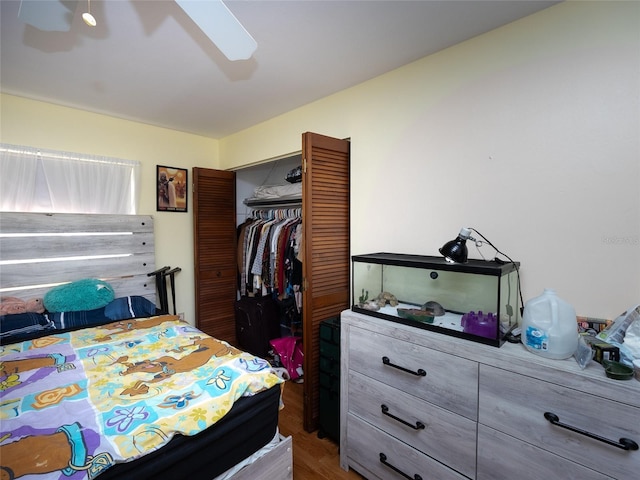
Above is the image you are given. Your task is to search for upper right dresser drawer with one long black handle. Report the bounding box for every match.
[478,365,640,479]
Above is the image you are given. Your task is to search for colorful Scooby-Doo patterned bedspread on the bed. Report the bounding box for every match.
[0,315,282,480]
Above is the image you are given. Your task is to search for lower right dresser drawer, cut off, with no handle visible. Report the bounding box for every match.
[477,425,608,480]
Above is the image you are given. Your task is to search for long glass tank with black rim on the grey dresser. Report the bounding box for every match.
[351,253,522,347]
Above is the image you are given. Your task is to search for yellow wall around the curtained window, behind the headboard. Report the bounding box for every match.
[0,95,219,323]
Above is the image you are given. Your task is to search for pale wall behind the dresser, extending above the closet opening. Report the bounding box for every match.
[220,2,640,318]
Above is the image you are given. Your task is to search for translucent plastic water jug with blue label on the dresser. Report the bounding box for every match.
[520,288,578,359]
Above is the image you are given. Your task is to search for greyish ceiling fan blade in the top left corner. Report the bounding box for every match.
[18,0,78,32]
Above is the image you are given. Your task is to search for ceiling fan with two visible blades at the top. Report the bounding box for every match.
[18,0,258,61]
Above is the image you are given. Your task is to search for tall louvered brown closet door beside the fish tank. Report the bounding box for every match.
[302,133,350,432]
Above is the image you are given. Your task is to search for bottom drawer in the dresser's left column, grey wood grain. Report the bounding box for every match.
[346,414,468,480]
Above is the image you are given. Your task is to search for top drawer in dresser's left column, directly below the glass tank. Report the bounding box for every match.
[348,327,478,420]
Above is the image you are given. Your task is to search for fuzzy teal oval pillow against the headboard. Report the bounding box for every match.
[44,278,115,312]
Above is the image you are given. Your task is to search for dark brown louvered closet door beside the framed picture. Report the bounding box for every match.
[193,167,238,345]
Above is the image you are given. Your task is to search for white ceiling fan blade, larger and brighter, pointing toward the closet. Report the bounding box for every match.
[175,0,258,61]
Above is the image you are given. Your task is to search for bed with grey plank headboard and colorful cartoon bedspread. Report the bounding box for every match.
[0,213,292,480]
